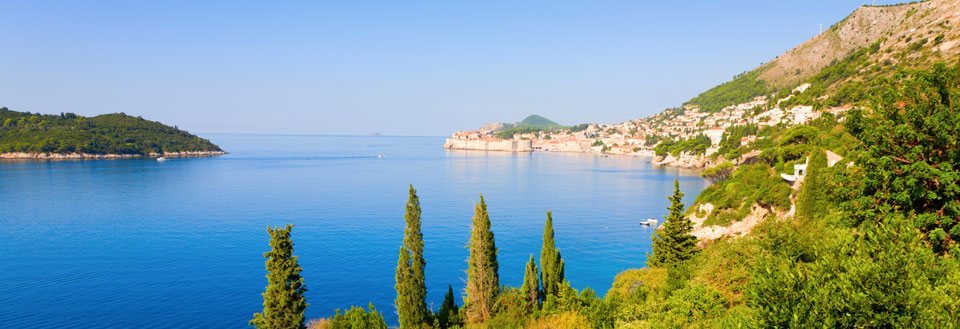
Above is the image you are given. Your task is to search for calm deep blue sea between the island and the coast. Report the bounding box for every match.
[0,135,706,328]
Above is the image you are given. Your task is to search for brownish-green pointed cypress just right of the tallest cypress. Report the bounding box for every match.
[463,195,500,323]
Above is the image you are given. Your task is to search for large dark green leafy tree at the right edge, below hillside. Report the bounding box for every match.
[856,64,960,253]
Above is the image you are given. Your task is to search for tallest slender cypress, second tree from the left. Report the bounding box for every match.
[395,185,430,328]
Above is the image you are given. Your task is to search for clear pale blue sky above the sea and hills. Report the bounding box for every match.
[0,0,912,136]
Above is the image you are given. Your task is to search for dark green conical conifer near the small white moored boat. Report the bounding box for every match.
[647,179,697,267]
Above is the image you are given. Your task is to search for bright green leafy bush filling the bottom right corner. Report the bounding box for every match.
[748,215,960,328]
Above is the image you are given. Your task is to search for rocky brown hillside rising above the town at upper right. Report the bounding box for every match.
[686,0,960,112]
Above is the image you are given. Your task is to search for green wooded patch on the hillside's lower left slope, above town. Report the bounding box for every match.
[686,69,775,112]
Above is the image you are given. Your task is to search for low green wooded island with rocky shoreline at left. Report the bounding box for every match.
[0,107,226,159]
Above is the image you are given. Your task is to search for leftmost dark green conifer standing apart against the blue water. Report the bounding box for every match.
[250,224,307,329]
